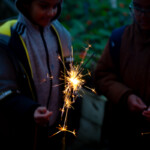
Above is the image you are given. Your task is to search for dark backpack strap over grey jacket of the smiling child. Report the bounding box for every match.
[8,30,36,99]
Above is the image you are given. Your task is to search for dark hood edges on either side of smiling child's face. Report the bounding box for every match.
[15,0,63,20]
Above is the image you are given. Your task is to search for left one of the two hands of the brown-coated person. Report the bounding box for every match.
[127,94,147,112]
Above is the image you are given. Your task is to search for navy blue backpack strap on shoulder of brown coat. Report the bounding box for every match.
[109,25,126,67]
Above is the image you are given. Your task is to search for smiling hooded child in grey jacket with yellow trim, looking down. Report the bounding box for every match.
[0,0,71,150]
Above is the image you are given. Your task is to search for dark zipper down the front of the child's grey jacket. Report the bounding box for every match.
[40,29,52,108]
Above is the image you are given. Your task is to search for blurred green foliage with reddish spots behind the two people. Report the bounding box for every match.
[60,0,131,71]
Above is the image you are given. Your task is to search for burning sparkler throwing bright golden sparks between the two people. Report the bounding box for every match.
[50,45,95,137]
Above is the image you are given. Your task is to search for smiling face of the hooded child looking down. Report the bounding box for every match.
[27,0,60,27]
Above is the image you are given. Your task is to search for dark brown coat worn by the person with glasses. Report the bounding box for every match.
[95,24,150,150]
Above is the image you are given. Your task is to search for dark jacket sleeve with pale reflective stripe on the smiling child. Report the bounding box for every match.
[0,47,39,117]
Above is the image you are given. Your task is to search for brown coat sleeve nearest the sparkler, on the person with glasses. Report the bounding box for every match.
[94,41,132,103]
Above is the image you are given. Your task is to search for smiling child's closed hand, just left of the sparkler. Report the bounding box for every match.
[34,106,52,126]
